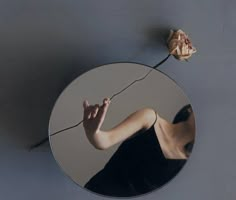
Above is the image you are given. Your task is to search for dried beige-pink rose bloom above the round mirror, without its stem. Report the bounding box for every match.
[167,29,197,61]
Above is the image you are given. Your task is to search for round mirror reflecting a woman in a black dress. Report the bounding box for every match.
[49,63,195,197]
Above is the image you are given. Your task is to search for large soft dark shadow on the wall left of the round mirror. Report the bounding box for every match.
[0,53,100,150]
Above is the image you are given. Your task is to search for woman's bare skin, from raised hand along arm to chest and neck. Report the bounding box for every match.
[83,98,195,159]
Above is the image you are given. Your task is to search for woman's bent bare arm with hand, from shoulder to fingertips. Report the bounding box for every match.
[83,98,156,150]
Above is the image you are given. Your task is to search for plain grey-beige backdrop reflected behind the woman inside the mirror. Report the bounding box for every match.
[49,63,190,186]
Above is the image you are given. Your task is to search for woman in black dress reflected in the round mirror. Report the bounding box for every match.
[83,98,195,197]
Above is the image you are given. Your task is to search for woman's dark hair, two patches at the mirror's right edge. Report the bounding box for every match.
[173,104,194,154]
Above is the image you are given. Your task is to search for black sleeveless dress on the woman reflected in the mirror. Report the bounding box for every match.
[84,123,186,197]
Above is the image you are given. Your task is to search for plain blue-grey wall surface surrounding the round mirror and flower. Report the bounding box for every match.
[0,0,236,200]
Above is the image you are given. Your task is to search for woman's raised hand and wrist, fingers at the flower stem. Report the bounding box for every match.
[83,98,110,149]
